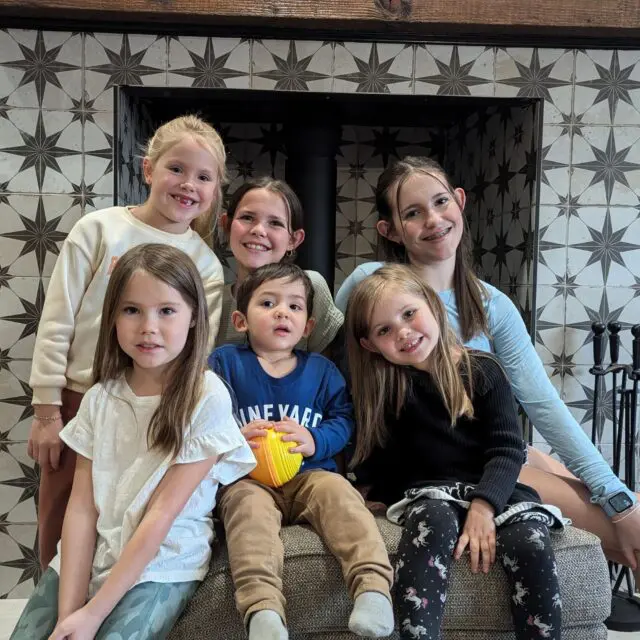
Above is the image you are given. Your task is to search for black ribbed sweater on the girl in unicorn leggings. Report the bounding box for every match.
[356,352,537,515]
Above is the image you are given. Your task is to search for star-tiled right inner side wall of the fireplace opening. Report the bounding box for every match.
[446,103,539,330]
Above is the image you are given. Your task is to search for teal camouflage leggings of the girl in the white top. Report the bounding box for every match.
[10,569,200,640]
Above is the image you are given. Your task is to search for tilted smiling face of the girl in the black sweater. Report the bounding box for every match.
[360,288,440,369]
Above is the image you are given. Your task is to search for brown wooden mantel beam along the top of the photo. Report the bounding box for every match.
[0,0,640,46]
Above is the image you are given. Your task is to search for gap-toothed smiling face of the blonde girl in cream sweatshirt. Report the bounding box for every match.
[143,136,218,233]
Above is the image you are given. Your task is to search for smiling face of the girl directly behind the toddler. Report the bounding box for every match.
[223,189,304,272]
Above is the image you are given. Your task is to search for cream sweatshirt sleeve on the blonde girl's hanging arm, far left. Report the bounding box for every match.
[29,232,93,404]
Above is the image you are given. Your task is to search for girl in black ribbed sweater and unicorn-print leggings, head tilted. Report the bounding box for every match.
[346,265,563,640]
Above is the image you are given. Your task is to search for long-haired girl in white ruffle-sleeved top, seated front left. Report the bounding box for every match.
[11,244,255,640]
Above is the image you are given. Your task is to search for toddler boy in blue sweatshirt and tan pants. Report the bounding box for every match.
[209,264,393,640]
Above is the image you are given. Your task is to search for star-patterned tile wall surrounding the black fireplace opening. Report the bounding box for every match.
[0,30,640,597]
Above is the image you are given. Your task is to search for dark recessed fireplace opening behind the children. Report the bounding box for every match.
[114,86,542,331]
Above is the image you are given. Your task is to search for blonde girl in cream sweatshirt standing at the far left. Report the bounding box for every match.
[27,116,226,568]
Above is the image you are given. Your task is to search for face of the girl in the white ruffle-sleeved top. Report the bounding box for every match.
[116,271,192,376]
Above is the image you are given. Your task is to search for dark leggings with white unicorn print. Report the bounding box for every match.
[395,498,562,640]
